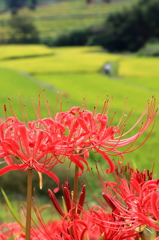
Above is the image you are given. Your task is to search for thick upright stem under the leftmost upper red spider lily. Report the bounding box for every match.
[26,169,32,240]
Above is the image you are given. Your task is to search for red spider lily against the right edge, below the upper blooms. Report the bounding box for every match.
[92,163,159,231]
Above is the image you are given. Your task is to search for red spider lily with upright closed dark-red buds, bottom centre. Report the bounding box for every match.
[31,182,139,240]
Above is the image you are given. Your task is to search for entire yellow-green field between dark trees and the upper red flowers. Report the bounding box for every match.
[0,45,159,173]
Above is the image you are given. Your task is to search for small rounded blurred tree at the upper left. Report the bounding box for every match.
[8,15,39,43]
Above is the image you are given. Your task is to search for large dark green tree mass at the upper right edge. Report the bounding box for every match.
[98,0,159,52]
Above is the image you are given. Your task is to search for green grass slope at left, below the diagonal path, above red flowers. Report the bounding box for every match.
[0,68,61,120]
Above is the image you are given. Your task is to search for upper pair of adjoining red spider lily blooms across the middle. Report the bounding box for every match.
[0,98,156,190]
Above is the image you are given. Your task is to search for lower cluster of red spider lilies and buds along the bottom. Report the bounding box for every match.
[0,165,159,240]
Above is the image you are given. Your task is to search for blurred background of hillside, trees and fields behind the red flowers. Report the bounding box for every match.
[0,0,159,222]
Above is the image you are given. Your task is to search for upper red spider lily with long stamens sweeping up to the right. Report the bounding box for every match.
[55,98,156,173]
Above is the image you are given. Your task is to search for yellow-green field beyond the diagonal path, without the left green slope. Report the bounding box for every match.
[0,45,159,110]
